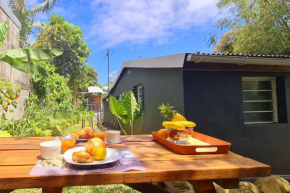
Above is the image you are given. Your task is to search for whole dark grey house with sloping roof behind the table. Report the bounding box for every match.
[103,53,290,174]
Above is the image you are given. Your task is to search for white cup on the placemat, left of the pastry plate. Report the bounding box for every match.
[39,141,61,159]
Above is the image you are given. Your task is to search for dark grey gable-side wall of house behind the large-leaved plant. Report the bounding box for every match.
[104,68,184,133]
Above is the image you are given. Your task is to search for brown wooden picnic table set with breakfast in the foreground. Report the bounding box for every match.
[0,135,271,192]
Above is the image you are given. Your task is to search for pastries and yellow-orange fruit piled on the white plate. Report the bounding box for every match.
[72,137,107,163]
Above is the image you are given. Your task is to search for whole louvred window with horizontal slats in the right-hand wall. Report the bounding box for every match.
[243,77,278,124]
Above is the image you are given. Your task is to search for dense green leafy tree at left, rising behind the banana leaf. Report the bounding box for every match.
[34,15,90,105]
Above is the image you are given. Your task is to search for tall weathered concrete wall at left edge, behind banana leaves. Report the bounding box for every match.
[0,1,30,119]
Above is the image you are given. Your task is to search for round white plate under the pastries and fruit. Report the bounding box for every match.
[63,147,119,166]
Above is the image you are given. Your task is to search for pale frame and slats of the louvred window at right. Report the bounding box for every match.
[242,77,278,124]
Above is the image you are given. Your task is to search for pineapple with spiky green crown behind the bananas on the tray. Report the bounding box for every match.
[158,103,186,121]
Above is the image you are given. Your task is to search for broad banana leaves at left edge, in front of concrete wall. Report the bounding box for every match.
[0,22,63,77]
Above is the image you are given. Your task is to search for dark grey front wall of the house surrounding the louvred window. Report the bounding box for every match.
[184,71,290,174]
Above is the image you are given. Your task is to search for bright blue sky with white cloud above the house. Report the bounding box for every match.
[27,0,222,85]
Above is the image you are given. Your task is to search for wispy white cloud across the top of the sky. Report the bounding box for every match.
[89,0,218,47]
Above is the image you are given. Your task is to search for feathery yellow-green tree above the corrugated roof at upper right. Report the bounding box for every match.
[209,0,290,55]
